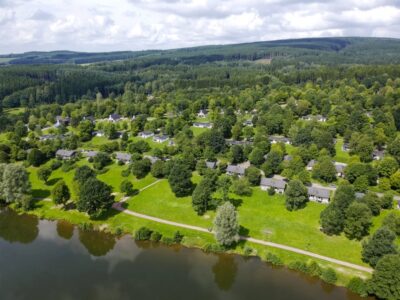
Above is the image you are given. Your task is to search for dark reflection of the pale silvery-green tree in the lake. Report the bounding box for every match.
[212,255,238,291]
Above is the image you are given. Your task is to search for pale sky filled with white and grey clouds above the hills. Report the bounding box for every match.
[0,0,400,54]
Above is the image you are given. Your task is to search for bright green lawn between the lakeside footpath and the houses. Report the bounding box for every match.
[128,180,396,265]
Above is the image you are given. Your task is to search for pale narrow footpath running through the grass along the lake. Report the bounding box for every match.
[113,179,373,273]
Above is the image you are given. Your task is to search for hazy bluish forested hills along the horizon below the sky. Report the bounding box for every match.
[0,37,400,65]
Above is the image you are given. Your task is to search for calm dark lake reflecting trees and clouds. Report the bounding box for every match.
[0,210,372,300]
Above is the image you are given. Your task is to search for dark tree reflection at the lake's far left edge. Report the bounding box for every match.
[0,209,39,244]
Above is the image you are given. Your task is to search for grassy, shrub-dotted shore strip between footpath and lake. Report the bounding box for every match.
[10,200,370,291]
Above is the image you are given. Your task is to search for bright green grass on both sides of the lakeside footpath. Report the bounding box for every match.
[22,159,400,285]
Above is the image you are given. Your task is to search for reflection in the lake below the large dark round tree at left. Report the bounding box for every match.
[79,229,115,256]
